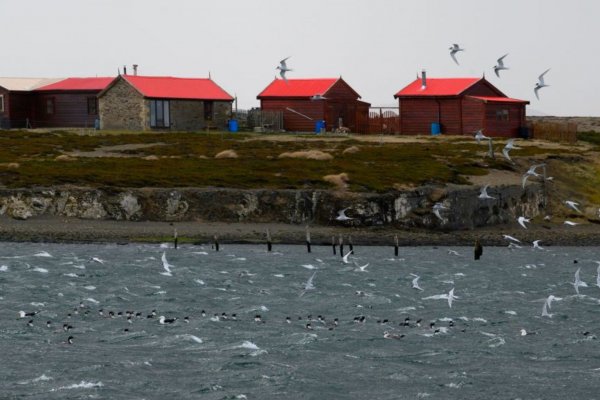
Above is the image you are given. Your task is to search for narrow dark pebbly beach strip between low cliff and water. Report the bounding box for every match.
[0,216,600,248]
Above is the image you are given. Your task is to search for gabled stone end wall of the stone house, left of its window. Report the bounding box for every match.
[98,79,145,130]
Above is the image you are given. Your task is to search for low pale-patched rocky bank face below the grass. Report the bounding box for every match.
[0,185,542,230]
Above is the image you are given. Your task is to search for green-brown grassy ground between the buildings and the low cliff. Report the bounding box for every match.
[0,130,592,192]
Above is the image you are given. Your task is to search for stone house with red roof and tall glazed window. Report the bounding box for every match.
[98,75,234,131]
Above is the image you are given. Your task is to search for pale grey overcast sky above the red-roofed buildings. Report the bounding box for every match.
[0,0,600,116]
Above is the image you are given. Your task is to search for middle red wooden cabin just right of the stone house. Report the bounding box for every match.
[256,77,370,133]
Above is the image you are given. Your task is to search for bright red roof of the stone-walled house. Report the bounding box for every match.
[121,75,233,101]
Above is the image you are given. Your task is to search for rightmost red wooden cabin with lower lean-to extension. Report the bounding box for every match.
[394,72,529,137]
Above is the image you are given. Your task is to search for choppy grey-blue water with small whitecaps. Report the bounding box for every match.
[0,243,600,399]
